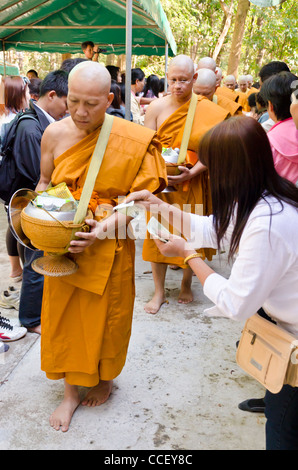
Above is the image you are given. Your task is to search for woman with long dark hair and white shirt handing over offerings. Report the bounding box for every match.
[123,116,298,450]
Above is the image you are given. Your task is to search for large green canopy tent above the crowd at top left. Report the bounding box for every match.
[0,0,176,116]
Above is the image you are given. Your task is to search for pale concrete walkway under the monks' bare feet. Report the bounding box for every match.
[0,206,265,455]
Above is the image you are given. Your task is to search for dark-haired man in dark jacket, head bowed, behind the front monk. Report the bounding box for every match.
[13,70,68,333]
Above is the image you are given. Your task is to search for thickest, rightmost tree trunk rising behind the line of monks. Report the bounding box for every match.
[227,0,250,78]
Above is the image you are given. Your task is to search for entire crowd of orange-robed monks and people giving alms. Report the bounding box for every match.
[0,48,298,449]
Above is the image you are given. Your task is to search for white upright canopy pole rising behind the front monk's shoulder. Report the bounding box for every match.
[125,0,132,121]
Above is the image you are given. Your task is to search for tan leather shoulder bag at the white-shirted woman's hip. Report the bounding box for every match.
[236,314,298,393]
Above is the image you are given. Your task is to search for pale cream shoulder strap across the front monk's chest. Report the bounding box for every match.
[73,114,114,224]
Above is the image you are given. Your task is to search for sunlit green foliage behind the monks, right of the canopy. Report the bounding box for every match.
[161,0,298,74]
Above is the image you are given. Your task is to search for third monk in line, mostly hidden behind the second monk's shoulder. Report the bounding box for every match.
[193,69,242,116]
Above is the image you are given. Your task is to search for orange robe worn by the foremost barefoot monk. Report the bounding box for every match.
[41,118,167,387]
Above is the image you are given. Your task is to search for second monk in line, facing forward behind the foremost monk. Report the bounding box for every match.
[143,55,229,314]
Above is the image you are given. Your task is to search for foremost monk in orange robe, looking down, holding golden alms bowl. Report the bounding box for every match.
[37,61,167,432]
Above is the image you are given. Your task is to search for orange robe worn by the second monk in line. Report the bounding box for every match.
[143,95,229,267]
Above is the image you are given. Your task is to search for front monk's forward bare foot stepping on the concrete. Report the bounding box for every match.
[50,385,80,432]
